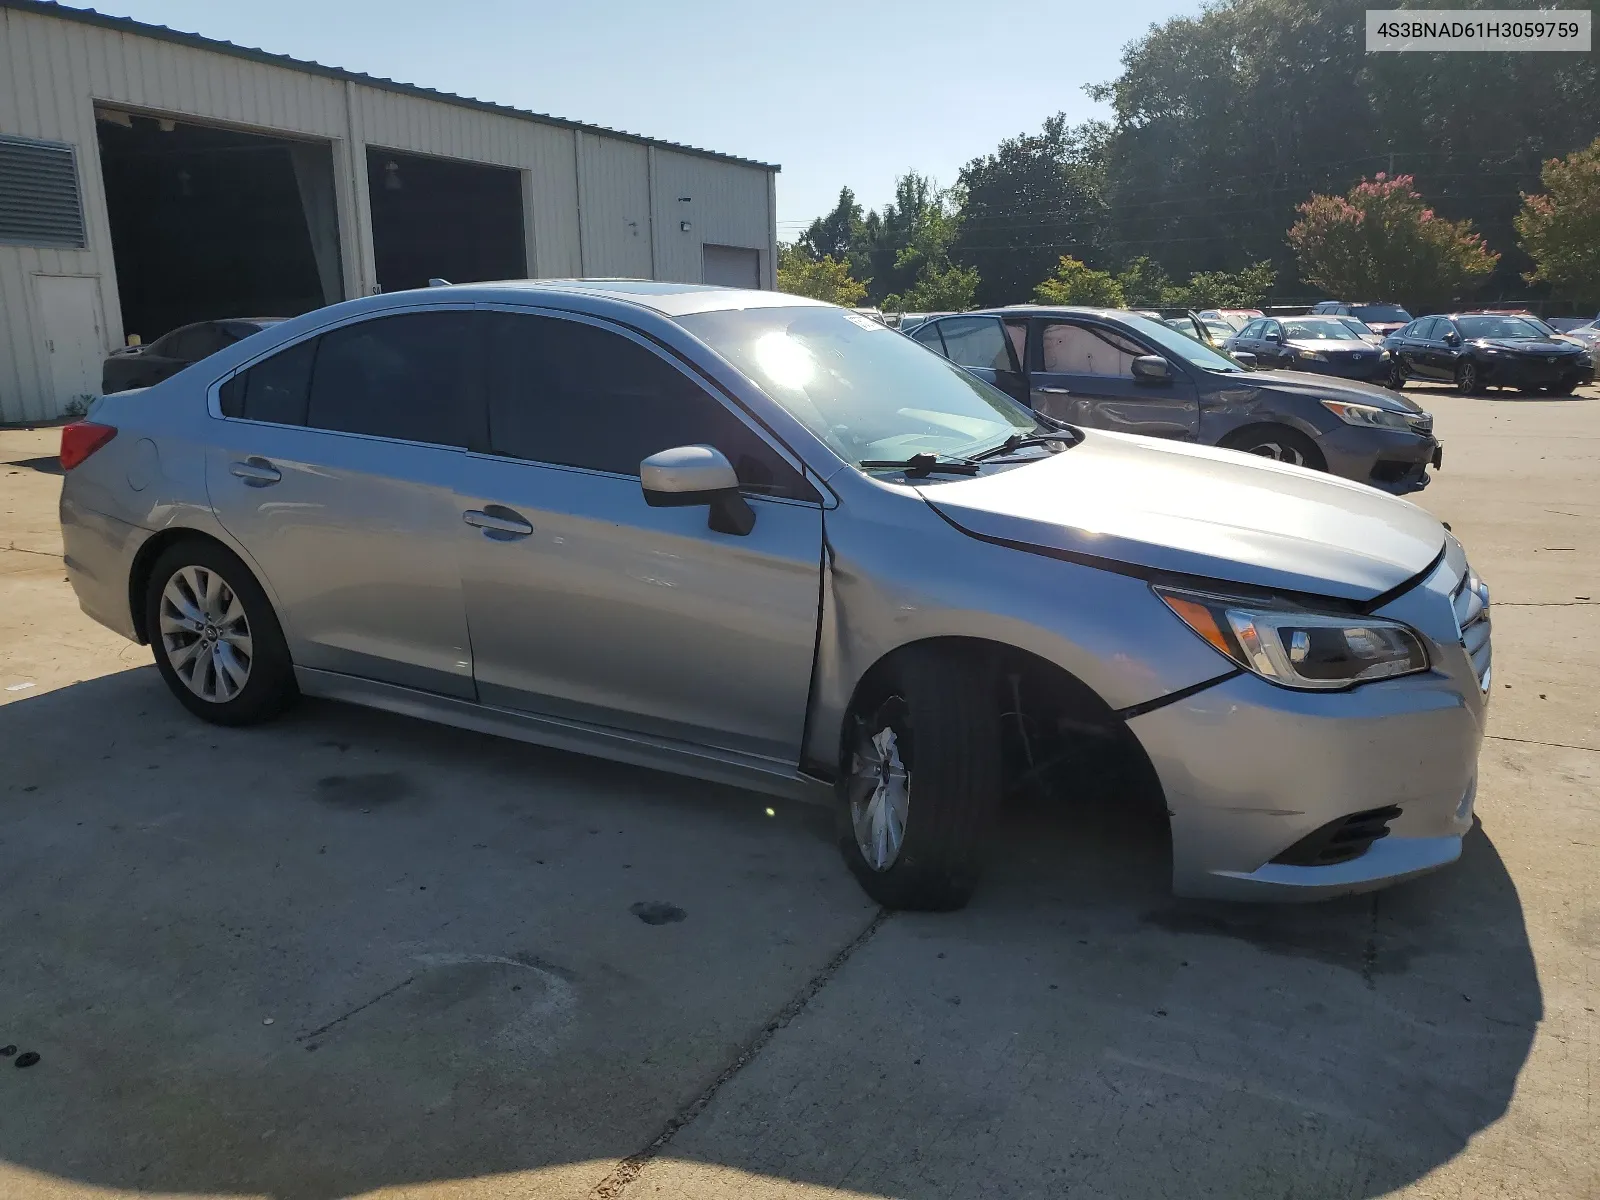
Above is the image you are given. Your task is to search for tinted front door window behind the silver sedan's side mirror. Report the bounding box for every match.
[486,312,818,501]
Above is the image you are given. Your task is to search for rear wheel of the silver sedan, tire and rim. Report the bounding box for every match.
[144,538,299,725]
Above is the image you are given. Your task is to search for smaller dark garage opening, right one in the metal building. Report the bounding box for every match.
[366,146,528,291]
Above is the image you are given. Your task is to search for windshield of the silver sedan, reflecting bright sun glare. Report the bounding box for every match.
[678,307,1036,464]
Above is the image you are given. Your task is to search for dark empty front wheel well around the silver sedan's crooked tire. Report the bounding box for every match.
[837,637,1166,814]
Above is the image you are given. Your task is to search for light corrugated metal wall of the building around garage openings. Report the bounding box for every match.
[0,8,774,422]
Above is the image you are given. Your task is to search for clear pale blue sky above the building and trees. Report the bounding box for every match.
[62,0,1200,238]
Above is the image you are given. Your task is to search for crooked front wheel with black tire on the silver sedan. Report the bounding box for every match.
[835,648,1002,912]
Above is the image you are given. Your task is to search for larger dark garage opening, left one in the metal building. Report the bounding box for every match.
[96,109,344,342]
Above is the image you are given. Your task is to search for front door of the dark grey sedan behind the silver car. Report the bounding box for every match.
[1027,317,1200,440]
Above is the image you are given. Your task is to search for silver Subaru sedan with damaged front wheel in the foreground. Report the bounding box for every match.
[61,280,1490,909]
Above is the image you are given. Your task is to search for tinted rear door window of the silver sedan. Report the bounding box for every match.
[305,312,477,446]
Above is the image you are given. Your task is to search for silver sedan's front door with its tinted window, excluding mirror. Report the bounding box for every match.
[456,312,822,763]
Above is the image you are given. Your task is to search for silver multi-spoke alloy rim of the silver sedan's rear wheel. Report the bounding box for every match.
[160,566,254,704]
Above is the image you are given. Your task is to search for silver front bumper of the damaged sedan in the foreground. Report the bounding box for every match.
[1128,646,1486,901]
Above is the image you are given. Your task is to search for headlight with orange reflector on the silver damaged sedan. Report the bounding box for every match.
[1155,587,1429,691]
